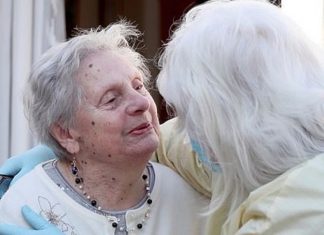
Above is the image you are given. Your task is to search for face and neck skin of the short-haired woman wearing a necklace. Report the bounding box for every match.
[54,51,159,208]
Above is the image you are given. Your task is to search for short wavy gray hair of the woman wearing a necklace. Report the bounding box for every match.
[24,21,150,157]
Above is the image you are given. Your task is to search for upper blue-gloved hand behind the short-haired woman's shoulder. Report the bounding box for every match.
[0,145,55,192]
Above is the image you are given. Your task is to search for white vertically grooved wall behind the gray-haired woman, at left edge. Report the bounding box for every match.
[0,0,65,164]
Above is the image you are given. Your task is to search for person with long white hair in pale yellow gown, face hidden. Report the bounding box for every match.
[3,0,324,235]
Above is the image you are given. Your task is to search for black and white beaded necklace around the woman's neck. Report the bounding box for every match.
[71,159,153,232]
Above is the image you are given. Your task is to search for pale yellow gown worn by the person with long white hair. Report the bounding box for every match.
[153,118,324,235]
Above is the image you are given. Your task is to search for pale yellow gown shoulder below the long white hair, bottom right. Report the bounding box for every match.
[224,155,324,234]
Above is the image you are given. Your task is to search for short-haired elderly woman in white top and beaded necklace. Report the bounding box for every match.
[0,22,207,235]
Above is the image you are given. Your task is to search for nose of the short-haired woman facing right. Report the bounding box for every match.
[127,92,150,114]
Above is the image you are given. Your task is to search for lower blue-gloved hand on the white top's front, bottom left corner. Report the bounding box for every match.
[0,206,63,235]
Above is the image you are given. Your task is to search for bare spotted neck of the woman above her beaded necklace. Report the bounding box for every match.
[58,157,151,210]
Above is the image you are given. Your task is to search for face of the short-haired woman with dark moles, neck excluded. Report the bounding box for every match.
[74,51,159,162]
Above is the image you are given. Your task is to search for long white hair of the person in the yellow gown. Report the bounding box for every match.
[157,0,324,215]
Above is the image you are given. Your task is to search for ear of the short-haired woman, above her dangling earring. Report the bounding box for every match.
[50,123,80,154]
